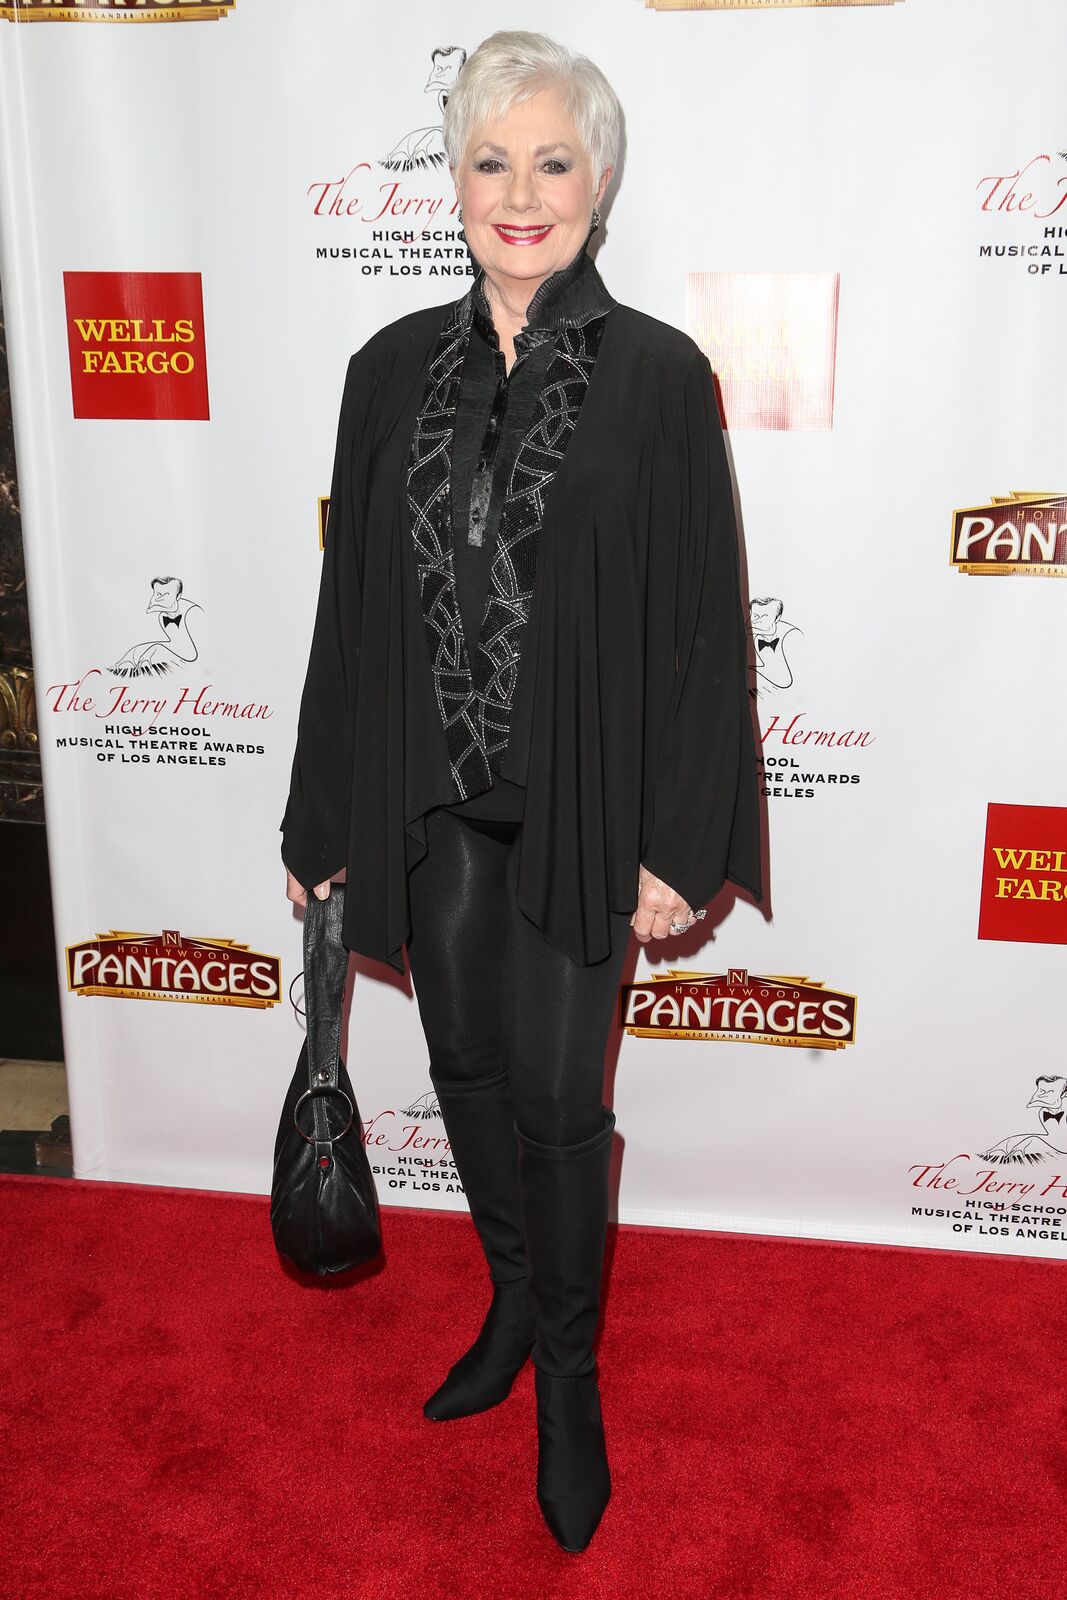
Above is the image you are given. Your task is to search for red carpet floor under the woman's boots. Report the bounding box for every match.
[0,1178,1067,1600]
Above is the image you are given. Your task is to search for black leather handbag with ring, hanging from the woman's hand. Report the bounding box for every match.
[270,883,382,1277]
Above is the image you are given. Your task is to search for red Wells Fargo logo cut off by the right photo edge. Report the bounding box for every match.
[977,805,1067,944]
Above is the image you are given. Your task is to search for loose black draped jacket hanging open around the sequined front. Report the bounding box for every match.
[282,302,761,973]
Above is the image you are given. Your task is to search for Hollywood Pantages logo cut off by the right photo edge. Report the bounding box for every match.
[952,491,1067,578]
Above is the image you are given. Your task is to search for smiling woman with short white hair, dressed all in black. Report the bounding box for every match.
[282,32,760,1550]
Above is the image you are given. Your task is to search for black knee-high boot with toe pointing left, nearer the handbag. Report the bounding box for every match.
[422,1069,534,1422]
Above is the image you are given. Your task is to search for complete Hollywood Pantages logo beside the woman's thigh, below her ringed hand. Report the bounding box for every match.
[619,966,856,1050]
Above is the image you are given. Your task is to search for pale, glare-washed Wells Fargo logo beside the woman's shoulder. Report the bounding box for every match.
[686,272,840,429]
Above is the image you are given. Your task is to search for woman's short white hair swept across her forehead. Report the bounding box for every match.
[442,29,622,187]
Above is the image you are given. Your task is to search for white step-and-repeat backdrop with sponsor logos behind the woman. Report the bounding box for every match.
[0,0,1067,1256]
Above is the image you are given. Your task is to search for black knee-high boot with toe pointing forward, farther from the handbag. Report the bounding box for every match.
[515,1106,614,1550]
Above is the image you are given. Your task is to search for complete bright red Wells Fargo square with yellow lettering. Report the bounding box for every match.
[62,272,210,421]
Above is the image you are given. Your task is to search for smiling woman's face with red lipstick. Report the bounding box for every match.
[453,88,611,304]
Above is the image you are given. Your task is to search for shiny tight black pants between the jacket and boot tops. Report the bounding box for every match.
[408,810,632,1144]
